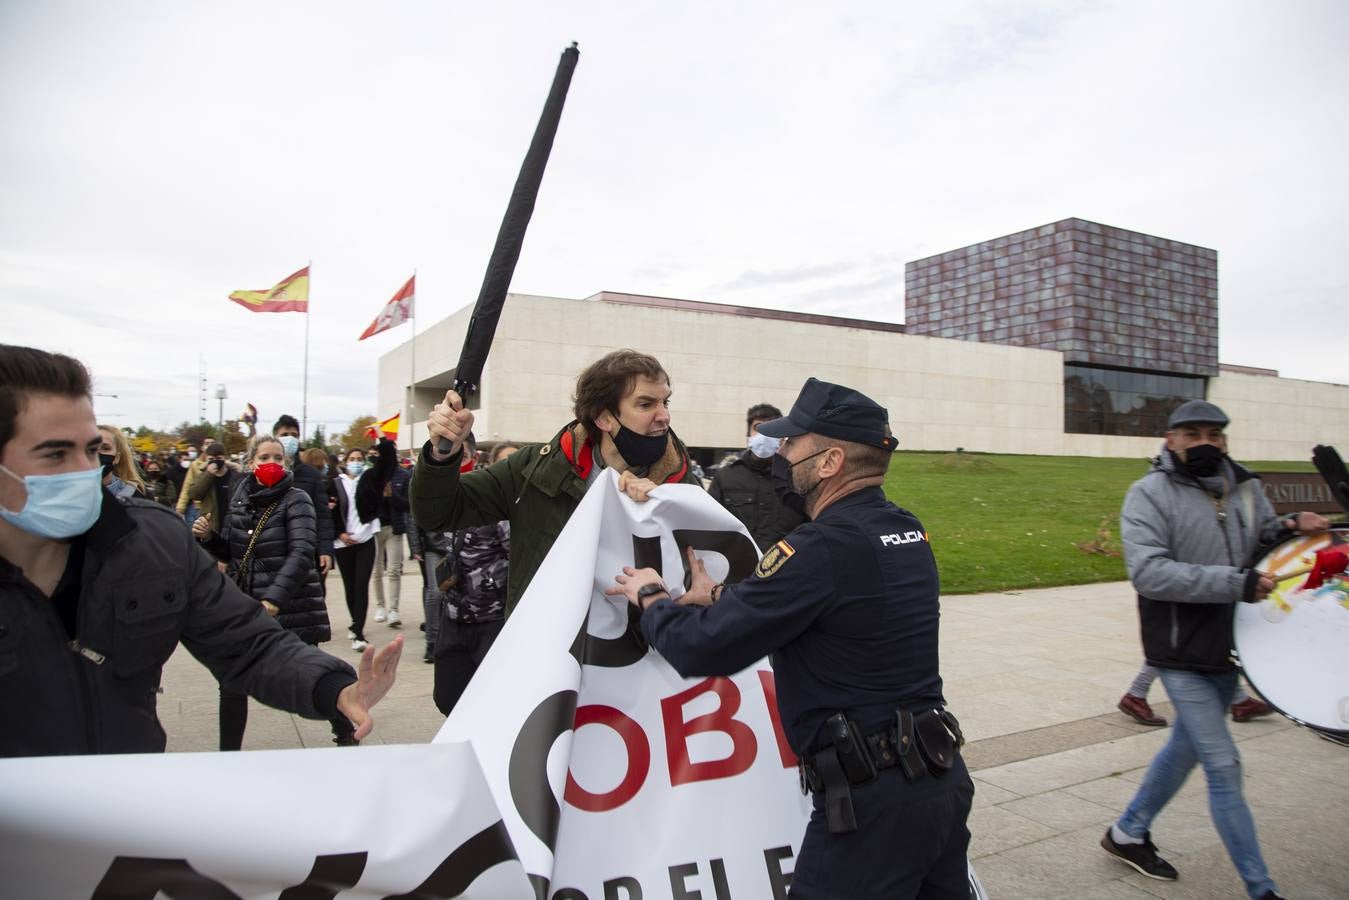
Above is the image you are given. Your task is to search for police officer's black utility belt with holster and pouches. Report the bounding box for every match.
[797,710,965,834]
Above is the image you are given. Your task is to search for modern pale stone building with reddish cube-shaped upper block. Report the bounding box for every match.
[378,219,1349,463]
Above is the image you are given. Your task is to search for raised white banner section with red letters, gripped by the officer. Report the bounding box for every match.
[436,472,809,900]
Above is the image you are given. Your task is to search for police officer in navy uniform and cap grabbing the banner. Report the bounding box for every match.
[608,378,974,900]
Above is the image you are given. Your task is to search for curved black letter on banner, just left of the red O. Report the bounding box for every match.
[510,691,576,899]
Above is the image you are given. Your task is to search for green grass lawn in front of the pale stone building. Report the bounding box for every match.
[885,453,1314,594]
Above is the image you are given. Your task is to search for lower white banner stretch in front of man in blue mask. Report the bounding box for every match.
[0,743,533,900]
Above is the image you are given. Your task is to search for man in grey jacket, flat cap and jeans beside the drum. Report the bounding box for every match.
[1101,399,1330,900]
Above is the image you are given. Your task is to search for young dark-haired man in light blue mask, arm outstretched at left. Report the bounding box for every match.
[0,345,402,756]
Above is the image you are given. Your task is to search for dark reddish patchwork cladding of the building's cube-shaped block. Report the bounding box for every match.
[904,219,1218,376]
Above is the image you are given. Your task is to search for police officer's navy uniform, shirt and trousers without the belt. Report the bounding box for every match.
[642,487,974,897]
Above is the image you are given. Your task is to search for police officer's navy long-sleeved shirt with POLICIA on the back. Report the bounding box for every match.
[641,487,943,756]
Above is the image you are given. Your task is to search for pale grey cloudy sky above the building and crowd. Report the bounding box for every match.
[0,0,1349,437]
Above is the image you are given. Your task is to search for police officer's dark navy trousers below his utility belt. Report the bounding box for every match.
[788,756,974,900]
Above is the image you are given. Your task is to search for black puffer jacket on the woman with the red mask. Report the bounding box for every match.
[209,472,332,644]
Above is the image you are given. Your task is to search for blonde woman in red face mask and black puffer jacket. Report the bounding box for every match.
[193,434,356,750]
